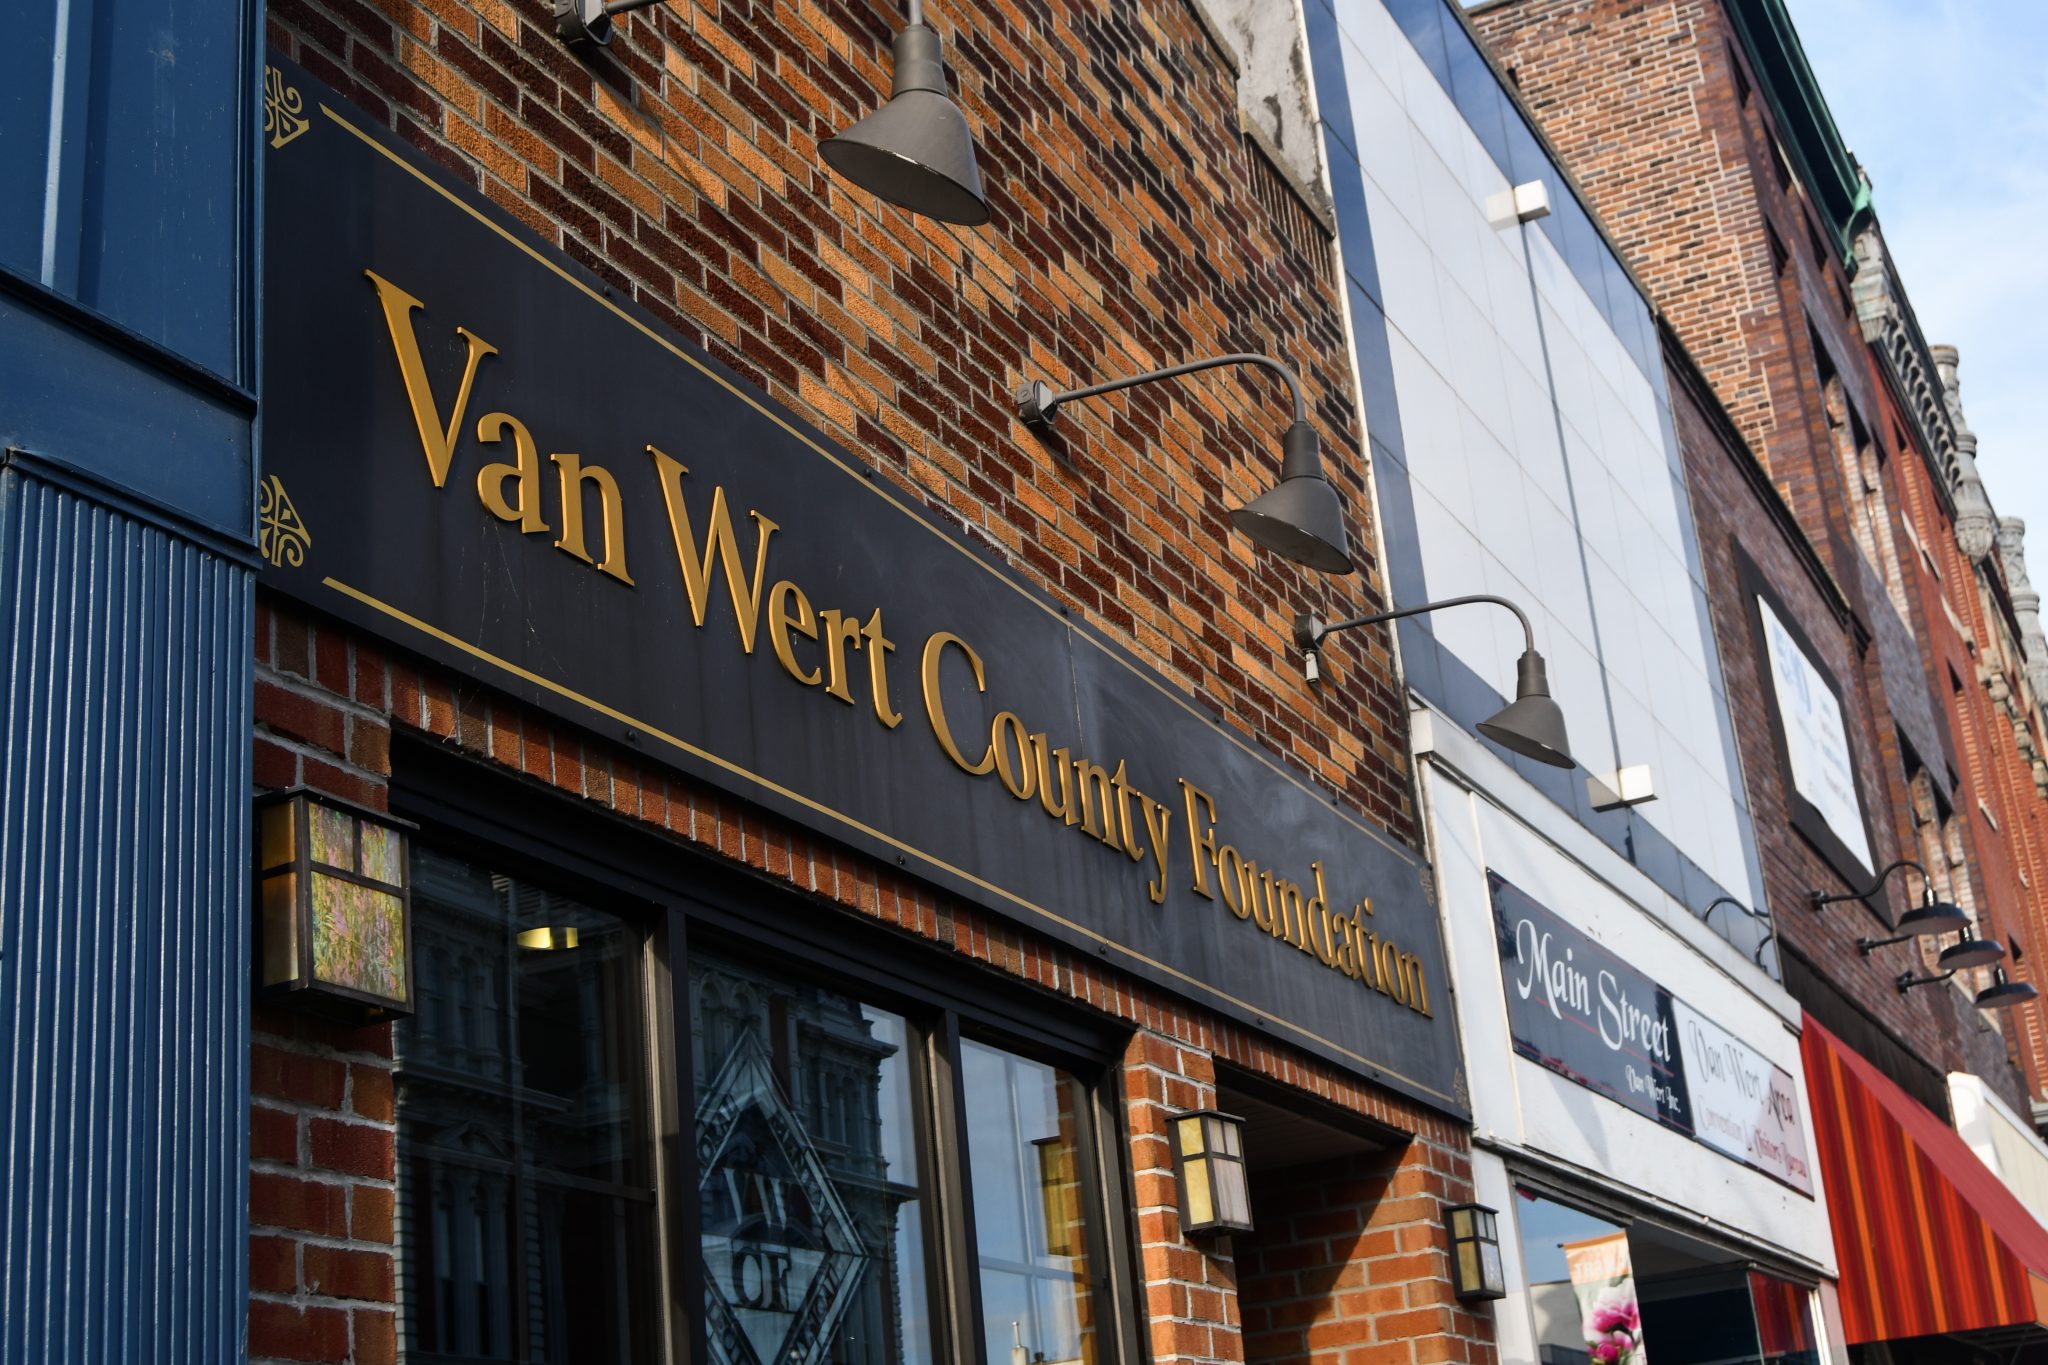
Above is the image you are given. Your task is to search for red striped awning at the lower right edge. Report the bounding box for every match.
[1800,1015,2048,1347]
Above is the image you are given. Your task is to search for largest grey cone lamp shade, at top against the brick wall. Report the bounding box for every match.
[817,25,989,227]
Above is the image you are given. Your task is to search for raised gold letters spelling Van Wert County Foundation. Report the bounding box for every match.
[356,270,1430,1031]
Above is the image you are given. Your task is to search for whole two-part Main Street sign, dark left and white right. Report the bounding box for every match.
[1487,872,1812,1195]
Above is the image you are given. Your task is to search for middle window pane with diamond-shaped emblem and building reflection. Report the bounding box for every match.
[690,958,932,1365]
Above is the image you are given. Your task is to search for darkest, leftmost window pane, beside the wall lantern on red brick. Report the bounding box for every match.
[395,847,655,1365]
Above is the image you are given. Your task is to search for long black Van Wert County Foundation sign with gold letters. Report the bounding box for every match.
[262,61,1462,1111]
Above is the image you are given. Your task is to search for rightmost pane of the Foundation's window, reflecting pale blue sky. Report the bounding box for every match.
[961,1042,1098,1365]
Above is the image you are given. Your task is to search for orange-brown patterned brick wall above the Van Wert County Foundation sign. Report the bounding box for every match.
[268,0,1417,841]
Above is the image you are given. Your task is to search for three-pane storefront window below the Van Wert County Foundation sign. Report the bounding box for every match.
[395,847,1110,1365]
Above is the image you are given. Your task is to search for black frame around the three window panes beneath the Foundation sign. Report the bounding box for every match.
[391,737,1147,1365]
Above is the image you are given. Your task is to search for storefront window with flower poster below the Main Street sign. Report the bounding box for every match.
[1516,1191,1819,1365]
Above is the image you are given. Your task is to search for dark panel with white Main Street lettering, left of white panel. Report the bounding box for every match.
[1487,872,1694,1138]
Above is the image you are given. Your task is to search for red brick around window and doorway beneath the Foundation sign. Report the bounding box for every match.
[250,593,1491,1365]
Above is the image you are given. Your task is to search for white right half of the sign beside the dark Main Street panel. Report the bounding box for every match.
[1671,997,1812,1195]
